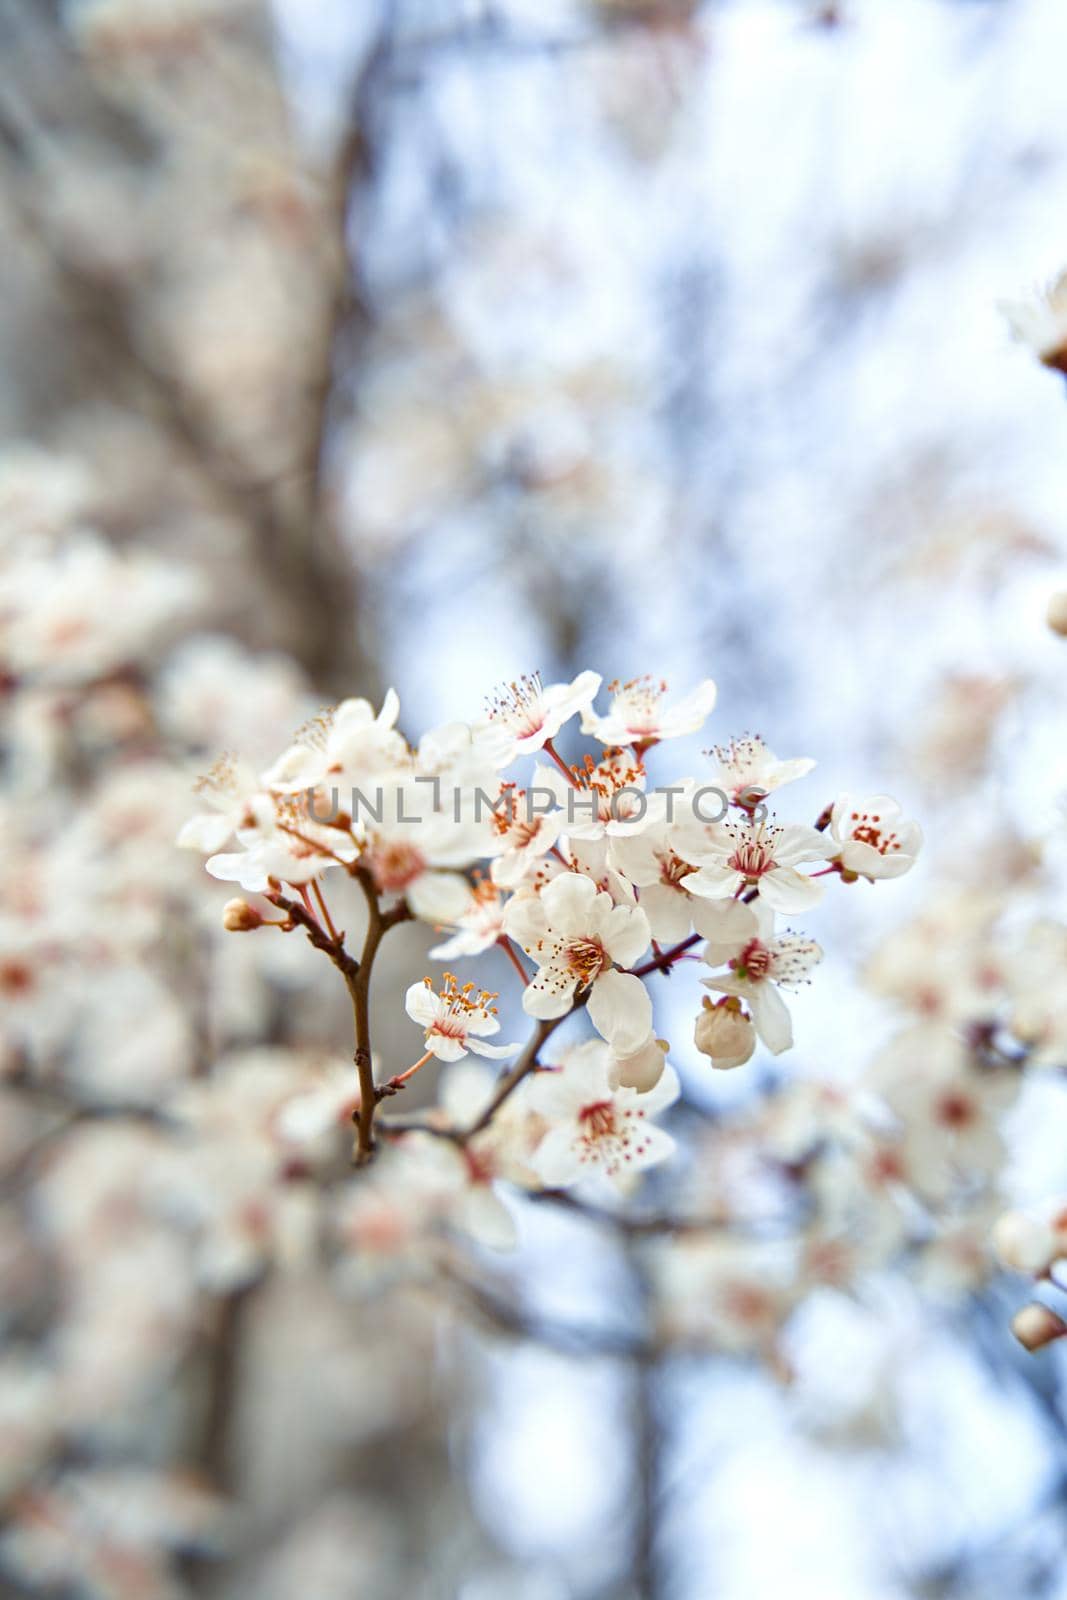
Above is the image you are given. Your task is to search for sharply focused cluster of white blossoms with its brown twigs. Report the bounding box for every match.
[179,672,921,1189]
